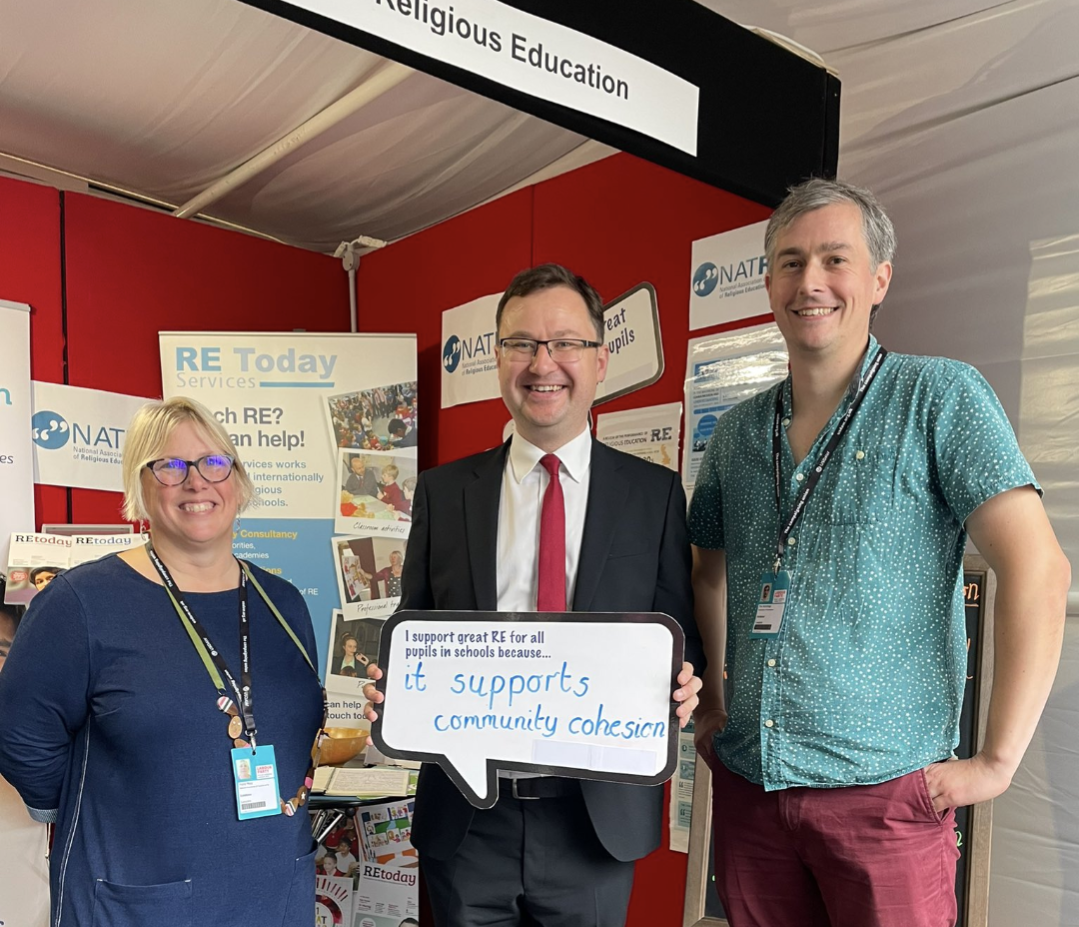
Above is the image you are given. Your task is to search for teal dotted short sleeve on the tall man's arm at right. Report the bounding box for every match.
[930,362,1041,523]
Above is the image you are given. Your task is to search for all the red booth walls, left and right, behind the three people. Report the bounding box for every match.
[0,148,769,927]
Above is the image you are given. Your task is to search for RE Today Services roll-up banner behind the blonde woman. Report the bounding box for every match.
[160,331,419,666]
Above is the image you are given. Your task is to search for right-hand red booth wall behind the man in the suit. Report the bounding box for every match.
[357,154,770,927]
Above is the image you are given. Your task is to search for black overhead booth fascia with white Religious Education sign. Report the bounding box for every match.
[242,0,839,205]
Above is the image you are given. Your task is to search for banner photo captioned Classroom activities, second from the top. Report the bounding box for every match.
[333,448,416,537]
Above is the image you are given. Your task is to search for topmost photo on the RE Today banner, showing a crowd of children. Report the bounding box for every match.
[326,381,416,451]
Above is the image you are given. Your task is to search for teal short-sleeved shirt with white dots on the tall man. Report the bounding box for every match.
[689,337,1040,791]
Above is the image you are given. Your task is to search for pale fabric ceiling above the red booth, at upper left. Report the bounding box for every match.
[0,0,585,251]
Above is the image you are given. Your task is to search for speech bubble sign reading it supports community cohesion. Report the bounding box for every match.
[371,611,685,808]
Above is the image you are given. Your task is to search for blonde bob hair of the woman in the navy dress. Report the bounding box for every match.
[122,396,257,521]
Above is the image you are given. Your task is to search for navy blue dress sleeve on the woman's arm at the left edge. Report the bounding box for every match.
[0,576,91,820]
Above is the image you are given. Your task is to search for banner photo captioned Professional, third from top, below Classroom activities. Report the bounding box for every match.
[330,533,408,618]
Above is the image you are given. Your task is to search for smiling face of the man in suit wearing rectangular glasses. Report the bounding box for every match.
[497,286,607,451]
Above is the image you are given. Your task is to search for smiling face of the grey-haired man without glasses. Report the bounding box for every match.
[765,203,891,364]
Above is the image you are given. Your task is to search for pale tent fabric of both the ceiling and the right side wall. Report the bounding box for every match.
[6,0,1079,915]
